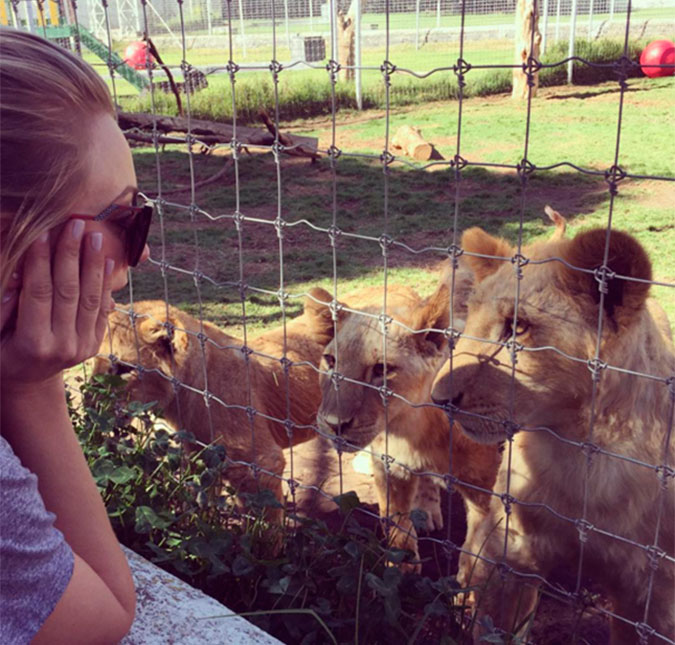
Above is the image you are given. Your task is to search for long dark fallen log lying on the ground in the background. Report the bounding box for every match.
[117,111,319,159]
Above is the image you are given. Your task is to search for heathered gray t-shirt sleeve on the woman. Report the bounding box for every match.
[0,437,74,645]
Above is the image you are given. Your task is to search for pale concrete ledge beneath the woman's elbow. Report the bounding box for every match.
[121,547,283,645]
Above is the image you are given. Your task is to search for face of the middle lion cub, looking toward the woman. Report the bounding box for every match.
[317,290,448,451]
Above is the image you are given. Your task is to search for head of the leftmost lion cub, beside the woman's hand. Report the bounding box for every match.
[93,301,189,408]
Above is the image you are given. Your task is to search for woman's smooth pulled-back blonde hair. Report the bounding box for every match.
[0,28,115,288]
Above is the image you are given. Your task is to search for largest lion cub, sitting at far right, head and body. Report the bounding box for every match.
[433,228,675,644]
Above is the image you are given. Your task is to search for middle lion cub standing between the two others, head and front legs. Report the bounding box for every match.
[314,285,500,571]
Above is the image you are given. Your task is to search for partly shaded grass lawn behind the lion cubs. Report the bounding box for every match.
[119,79,675,333]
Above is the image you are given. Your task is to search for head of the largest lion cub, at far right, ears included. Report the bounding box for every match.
[432,229,651,443]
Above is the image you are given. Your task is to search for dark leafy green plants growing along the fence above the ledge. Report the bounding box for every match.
[70,375,470,645]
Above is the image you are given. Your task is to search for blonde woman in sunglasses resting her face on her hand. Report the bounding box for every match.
[0,29,152,645]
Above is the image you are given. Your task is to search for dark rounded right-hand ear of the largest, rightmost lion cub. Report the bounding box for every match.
[561,229,652,328]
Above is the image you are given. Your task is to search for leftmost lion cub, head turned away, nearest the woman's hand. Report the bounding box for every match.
[93,299,322,521]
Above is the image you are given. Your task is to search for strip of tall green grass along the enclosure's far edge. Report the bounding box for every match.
[122,39,656,124]
